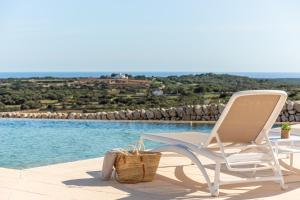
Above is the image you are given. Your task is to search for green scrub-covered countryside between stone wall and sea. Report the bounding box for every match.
[0,73,300,112]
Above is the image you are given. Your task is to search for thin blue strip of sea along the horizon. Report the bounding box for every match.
[0,71,300,79]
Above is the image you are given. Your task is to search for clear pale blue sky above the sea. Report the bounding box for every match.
[0,0,300,72]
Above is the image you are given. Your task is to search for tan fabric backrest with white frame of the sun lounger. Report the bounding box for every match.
[208,90,287,143]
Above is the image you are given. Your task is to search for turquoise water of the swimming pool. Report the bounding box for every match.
[0,119,212,169]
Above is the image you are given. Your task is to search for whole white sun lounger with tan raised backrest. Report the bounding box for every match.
[141,90,287,196]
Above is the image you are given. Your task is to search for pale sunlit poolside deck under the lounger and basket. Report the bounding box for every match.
[0,154,300,200]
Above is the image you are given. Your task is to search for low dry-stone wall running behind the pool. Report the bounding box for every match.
[0,101,300,122]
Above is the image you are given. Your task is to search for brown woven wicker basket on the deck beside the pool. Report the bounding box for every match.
[114,151,161,183]
